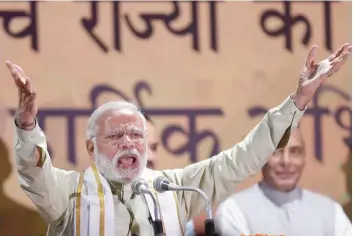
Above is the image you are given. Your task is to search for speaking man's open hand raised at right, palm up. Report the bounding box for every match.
[293,43,352,110]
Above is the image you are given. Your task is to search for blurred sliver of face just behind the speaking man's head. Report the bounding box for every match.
[147,121,159,169]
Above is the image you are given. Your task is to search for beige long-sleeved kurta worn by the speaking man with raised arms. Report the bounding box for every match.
[15,97,303,236]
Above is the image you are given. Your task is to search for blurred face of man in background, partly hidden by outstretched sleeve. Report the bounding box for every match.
[262,129,305,192]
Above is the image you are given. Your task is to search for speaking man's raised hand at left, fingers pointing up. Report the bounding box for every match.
[6,61,38,129]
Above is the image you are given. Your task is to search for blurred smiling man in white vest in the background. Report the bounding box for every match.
[216,128,352,236]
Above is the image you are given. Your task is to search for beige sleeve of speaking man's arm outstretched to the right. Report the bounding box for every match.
[163,97,304,220]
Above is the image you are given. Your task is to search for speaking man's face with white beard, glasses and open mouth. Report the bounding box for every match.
[93,108,147,183]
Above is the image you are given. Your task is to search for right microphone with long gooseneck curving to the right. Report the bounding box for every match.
[153,176,217,236]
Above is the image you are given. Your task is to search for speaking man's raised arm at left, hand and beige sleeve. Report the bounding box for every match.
[7,62,76,224]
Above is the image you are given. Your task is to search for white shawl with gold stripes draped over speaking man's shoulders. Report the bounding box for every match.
[73,164,184,236]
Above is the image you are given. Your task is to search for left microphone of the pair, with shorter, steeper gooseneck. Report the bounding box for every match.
[131,179,165,236]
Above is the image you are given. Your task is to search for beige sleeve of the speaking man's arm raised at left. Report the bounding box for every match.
[15,121,70,223]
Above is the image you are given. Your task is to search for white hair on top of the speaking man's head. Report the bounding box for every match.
[86,101,146,140]
